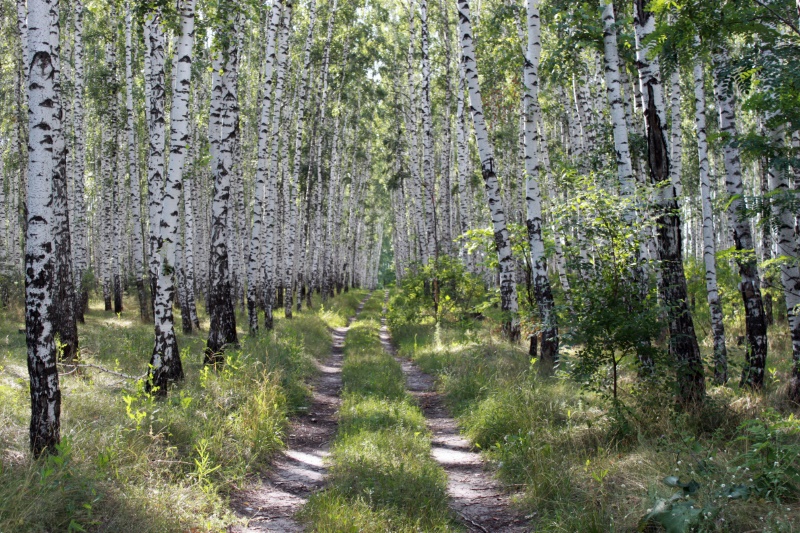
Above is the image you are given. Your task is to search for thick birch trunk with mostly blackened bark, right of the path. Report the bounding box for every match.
[634,0,705,406]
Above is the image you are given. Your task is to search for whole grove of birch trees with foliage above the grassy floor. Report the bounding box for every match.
[9,0,800,462]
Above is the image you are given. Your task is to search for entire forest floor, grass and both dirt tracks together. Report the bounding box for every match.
[0,284,800,533]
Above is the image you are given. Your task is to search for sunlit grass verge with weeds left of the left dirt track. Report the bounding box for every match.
[0,291,364,532]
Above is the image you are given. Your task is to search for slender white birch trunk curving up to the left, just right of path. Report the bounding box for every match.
[458,0,520,341]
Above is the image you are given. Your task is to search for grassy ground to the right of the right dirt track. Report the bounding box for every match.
[392,308,800,532]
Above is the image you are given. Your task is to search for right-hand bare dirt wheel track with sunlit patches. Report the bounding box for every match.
[380,293,531,533]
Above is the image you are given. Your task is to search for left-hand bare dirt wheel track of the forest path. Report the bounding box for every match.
[230,295,370,533]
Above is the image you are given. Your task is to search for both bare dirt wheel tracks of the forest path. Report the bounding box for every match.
[231,293,530,533]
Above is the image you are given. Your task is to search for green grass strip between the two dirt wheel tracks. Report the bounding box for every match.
[301,295,453,532]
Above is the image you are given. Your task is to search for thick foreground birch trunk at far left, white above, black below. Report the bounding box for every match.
[24,0,63,456]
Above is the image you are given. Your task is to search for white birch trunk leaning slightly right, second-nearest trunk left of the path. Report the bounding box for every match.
[148,0,196,395]
